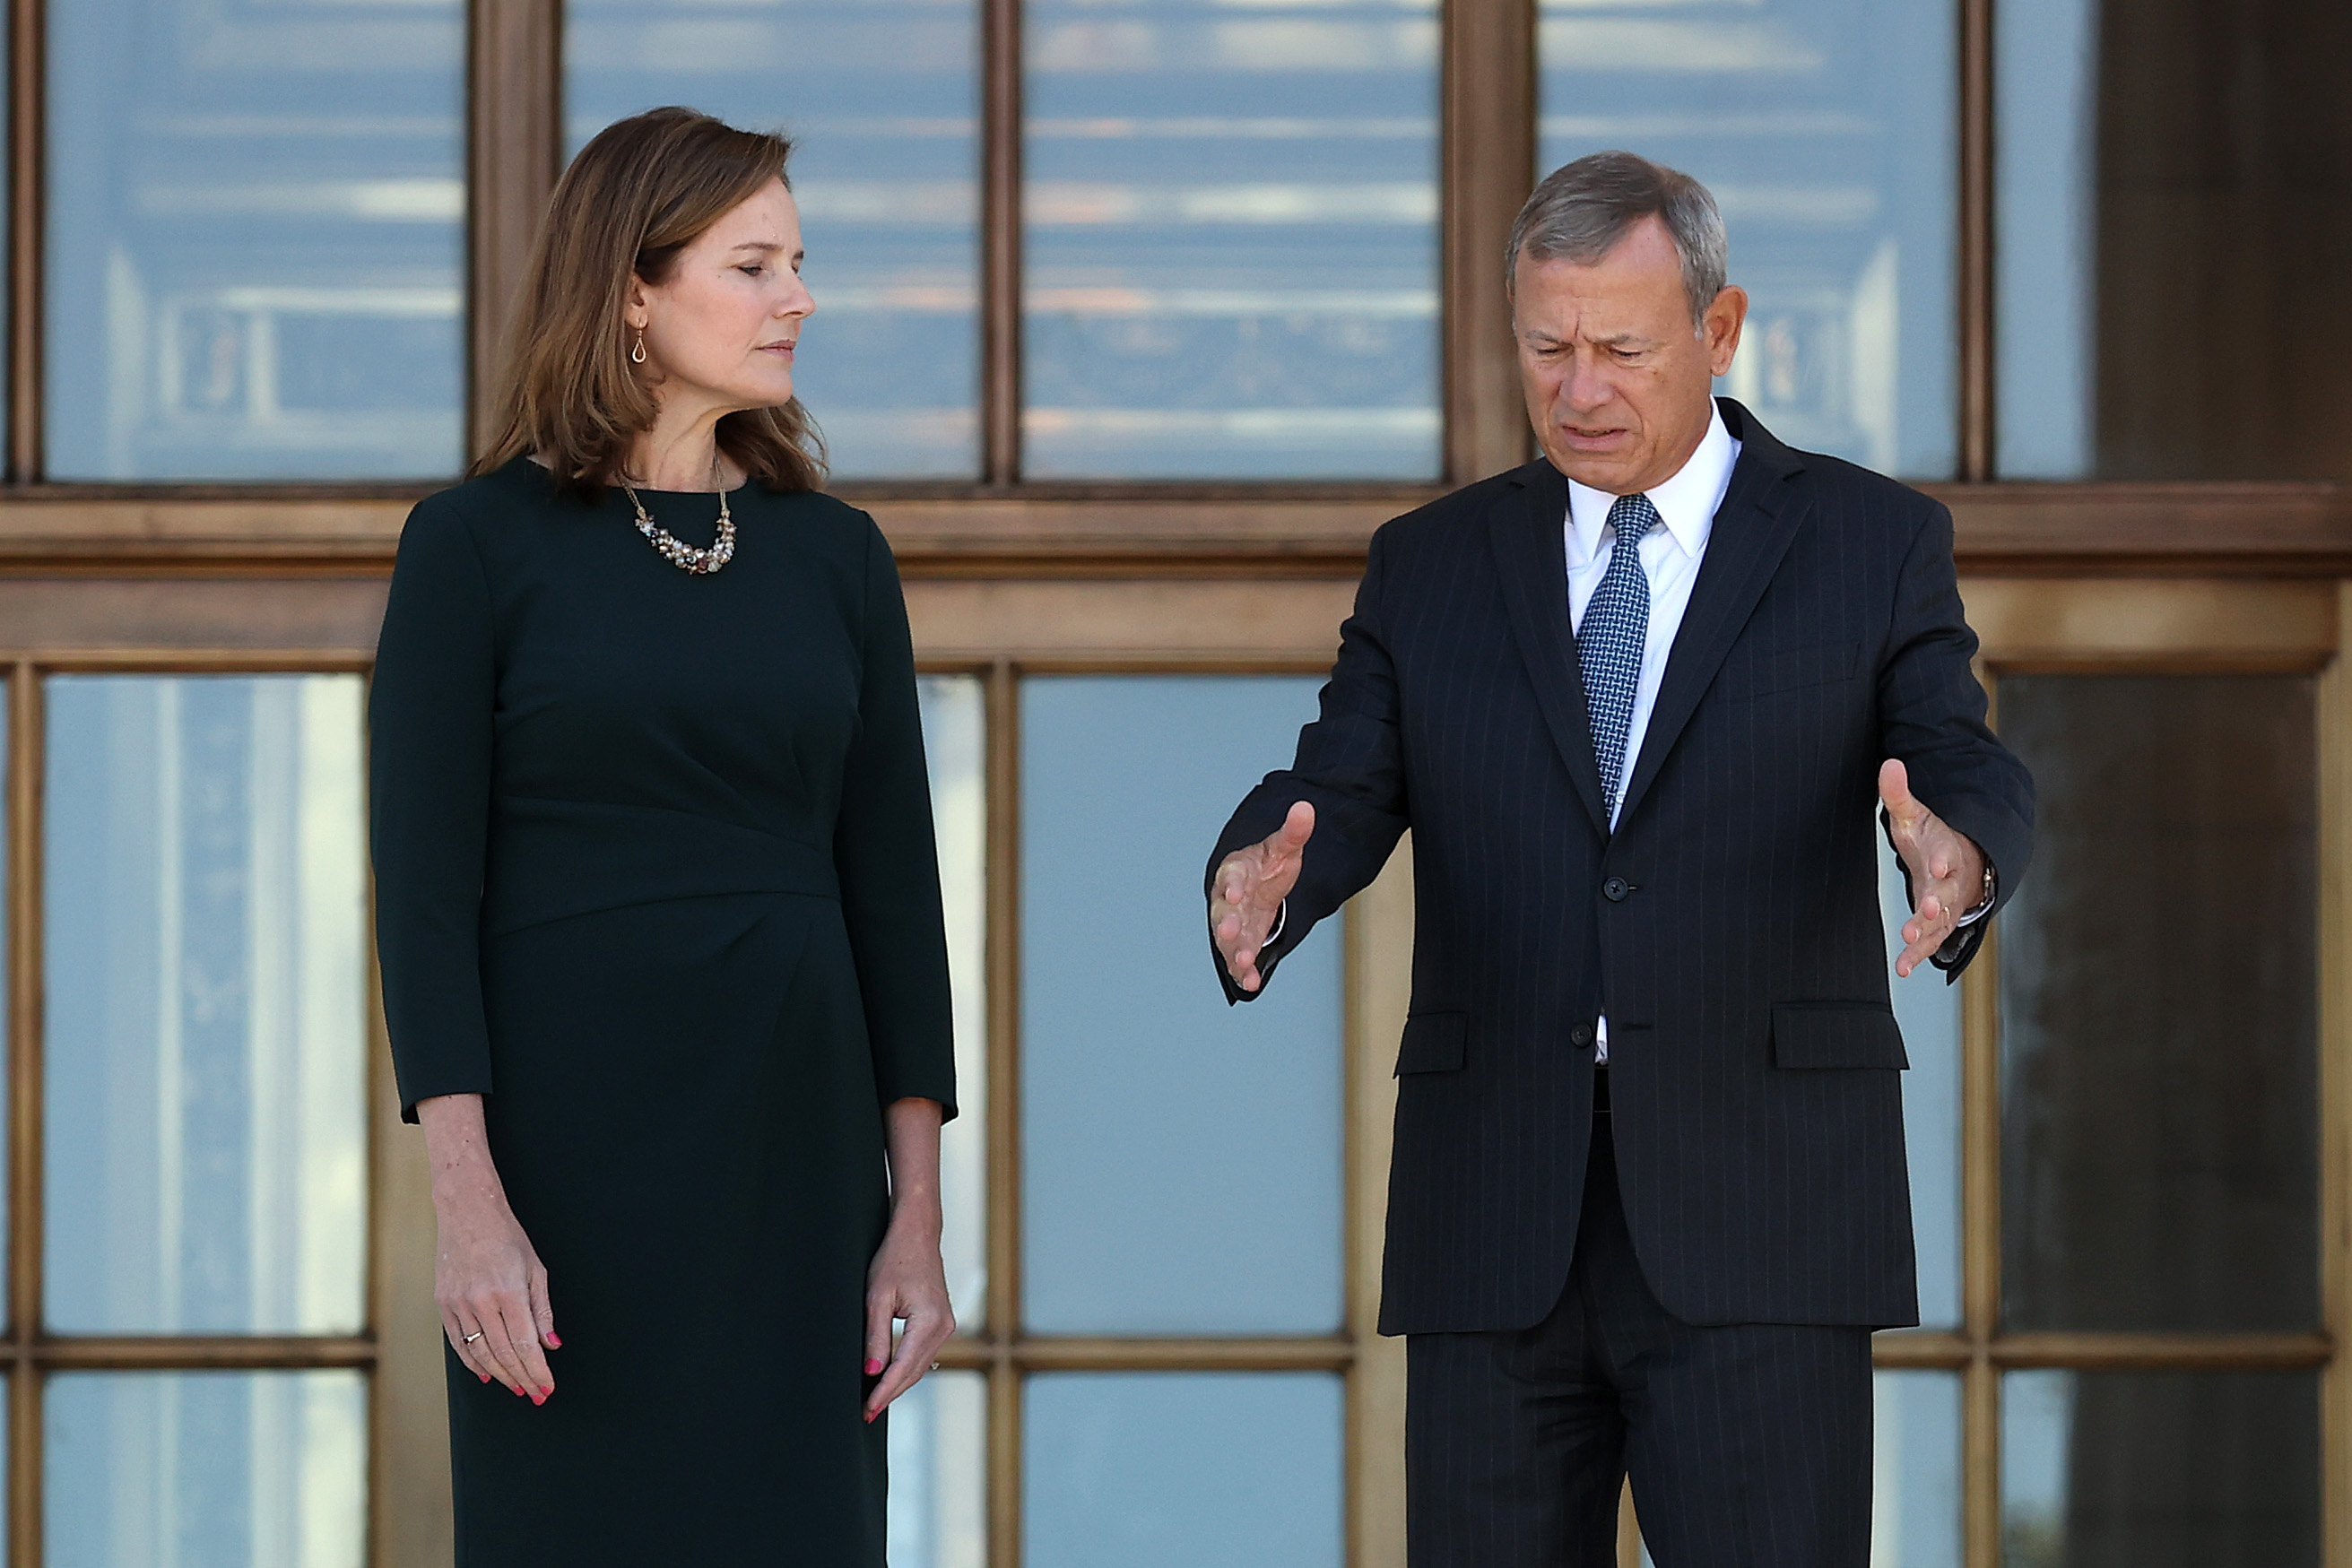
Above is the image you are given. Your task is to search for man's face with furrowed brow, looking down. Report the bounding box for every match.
[1513,216,1748,496]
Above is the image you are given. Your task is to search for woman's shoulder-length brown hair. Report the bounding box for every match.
[473,108,826,498]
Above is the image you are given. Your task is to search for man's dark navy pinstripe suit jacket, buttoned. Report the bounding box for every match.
[1209,400,2032,1333]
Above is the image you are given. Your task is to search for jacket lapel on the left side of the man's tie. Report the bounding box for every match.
[1487,458,1618,836]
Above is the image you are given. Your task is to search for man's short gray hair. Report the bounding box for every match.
[1503,152,1731,326]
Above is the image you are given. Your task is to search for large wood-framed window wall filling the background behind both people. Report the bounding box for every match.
[0,0,2352,1568]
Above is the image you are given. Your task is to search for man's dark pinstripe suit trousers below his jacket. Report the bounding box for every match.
[1404,1090,1872,1568]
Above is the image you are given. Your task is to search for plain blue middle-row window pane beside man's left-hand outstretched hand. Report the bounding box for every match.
[1020,675,1341,1333]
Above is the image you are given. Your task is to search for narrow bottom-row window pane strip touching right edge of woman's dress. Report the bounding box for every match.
[889,1363,988,1568]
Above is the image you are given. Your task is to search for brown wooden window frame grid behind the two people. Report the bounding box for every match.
[0,0,2352,1568]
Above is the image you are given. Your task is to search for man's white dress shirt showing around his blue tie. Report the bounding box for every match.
[1567,409,1740,1062]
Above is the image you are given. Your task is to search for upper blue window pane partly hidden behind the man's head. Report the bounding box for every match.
[1542,0,1959,477]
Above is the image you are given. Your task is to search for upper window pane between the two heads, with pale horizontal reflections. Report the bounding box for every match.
[1023,0,1439,480]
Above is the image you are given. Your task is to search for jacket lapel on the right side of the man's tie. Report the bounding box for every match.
[1627,397,1809,820]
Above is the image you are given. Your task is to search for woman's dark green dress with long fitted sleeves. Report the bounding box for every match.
[369,458,955,1568]
